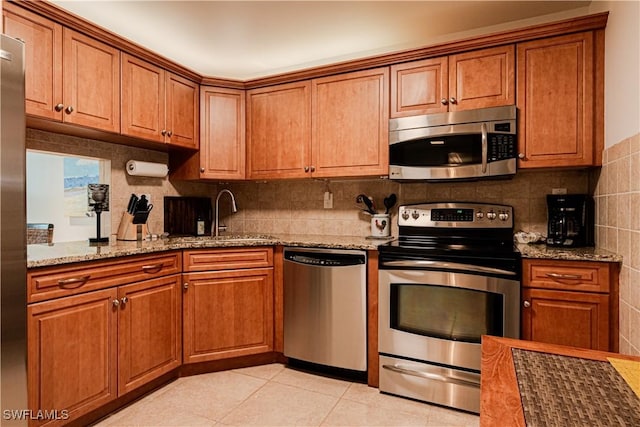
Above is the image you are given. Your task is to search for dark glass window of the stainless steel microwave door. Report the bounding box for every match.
[389,134,482,167]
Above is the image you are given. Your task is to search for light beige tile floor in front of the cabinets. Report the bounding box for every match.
[96,364,479,427]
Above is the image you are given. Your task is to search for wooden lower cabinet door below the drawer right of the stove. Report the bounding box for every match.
[522,288,611,351]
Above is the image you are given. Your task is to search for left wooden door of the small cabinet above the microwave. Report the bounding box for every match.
[391,57,449,118]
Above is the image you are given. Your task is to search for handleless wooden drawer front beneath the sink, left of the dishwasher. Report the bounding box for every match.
[183,247,273,272]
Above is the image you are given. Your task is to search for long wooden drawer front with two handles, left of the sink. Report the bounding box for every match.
[27,251,182,303]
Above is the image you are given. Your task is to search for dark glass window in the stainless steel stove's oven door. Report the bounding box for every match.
[390,284,503,343]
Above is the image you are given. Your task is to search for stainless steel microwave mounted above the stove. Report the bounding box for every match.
[389,105,517,181]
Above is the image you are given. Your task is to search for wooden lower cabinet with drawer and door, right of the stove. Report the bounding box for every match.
[522,259,618,352]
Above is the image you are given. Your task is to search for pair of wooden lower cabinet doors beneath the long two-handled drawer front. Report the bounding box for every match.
[27,274,181,426]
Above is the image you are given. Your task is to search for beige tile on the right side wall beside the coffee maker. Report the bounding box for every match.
[593,134,640,355]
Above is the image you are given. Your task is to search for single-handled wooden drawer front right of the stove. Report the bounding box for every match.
[522,259,610,293]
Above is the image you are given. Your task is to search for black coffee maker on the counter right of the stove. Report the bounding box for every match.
[547,194,594,248]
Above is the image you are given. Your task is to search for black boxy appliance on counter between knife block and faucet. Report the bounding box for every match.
[164,196,213,236]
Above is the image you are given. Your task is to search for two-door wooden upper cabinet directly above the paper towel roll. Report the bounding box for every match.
[122,53,199,148]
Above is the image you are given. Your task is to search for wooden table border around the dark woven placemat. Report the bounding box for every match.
[480,335,640,427]
